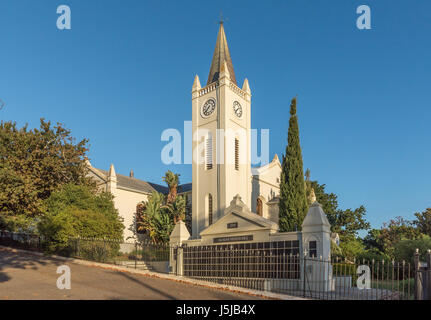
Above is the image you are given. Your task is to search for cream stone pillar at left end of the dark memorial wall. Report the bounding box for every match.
[169,220,190,276]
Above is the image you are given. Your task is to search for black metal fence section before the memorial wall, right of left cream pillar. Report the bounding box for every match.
[174,241,417,300]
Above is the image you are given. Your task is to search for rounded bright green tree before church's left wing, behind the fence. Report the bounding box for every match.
[38,184,124,251]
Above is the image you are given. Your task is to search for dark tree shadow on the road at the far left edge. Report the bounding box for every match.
[0,248,61,283]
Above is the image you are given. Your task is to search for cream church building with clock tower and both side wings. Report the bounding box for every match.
[88,22,281,239]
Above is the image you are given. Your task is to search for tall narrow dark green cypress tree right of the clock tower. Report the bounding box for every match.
[279,98,308,232]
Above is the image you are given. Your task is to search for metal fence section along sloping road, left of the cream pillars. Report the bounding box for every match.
[0,231,169,272]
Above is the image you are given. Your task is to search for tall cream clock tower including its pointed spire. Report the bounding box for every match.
[192,22,251,239]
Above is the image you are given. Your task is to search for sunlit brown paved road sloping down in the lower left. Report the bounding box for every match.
[0,248,264,300]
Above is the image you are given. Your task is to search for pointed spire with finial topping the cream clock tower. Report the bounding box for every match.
[207,21,237,85]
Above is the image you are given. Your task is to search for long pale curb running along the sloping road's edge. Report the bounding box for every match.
[0,245,310,300]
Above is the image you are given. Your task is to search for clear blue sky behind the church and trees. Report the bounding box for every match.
[0,0,431,232]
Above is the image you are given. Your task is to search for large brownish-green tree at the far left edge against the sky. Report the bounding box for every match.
[0,119,92,229]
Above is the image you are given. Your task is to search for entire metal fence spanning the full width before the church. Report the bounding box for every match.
[0,231,431,300]
